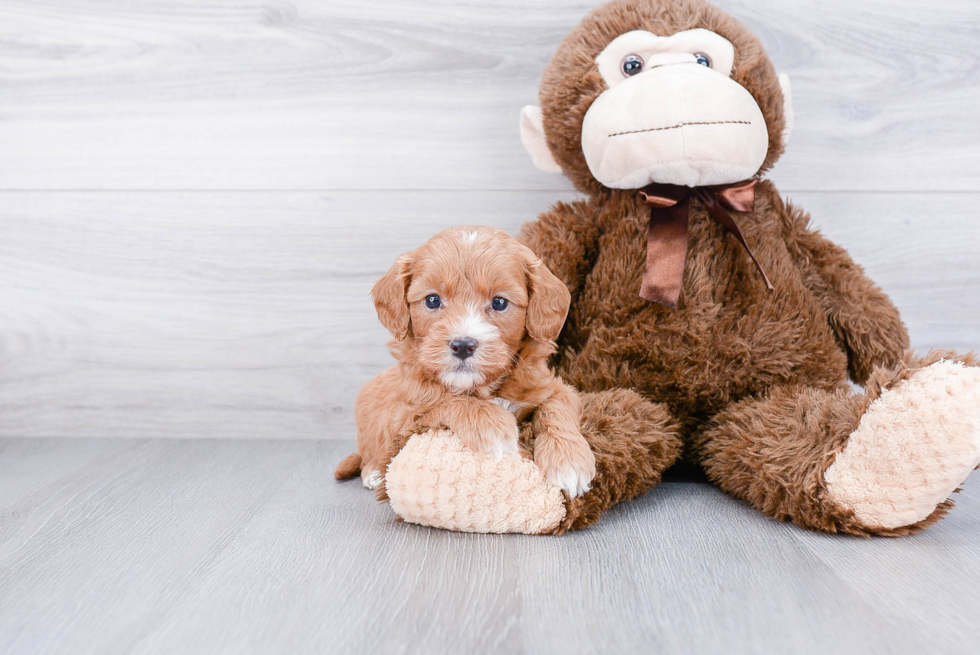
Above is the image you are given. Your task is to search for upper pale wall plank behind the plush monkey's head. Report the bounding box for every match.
[0,0,980,191]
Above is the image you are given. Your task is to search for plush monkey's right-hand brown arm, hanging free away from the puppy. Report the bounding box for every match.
[777,202,909,384]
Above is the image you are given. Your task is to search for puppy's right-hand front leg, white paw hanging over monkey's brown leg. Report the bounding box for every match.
[532,379,595,498]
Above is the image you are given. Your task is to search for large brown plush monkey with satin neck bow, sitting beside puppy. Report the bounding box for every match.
[368,0,980,535]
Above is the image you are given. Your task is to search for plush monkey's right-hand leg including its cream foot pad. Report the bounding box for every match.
[695,353,980,536]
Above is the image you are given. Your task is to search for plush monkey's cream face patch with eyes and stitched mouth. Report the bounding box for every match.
[582,29,769,189]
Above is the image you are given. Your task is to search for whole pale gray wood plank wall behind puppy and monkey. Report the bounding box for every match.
[0,0,980,439]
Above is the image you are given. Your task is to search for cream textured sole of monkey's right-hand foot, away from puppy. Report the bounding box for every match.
[824,361,980,528]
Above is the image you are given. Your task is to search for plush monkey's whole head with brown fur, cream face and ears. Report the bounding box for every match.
[521,0,792,193]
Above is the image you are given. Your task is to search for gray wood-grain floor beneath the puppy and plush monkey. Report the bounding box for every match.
[0,439,980,655]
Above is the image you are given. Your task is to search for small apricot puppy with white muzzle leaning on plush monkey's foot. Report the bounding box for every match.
[335,227,595,497]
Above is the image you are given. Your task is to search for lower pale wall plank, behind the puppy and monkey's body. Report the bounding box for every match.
[0,191,980,438]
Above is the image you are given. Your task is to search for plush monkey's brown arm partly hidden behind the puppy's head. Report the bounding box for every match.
[517,201,599,302]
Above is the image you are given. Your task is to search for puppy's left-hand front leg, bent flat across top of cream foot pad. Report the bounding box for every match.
[424,396,518,459]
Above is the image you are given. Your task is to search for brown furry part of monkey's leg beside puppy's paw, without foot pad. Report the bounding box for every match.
[556,389,682,534]
